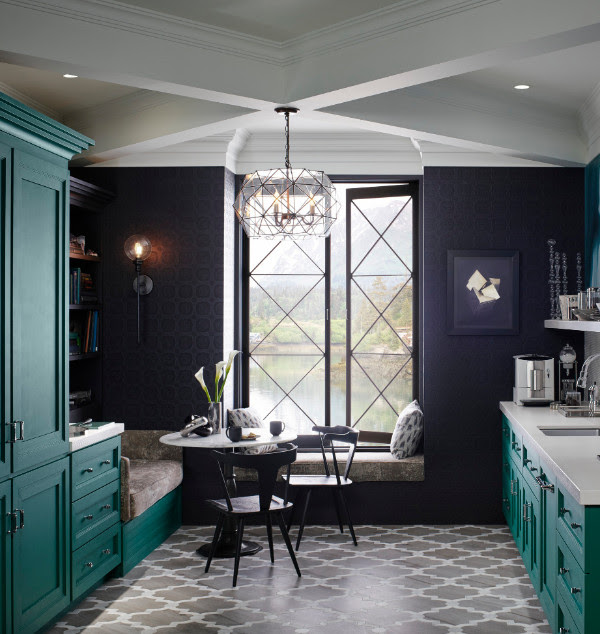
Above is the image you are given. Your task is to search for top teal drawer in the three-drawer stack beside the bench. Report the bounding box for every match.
[71,436,121,500]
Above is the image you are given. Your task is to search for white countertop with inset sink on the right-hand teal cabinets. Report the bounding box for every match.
[500,401,600,506]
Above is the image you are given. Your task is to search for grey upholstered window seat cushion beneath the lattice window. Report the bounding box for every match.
[235,451,425,482]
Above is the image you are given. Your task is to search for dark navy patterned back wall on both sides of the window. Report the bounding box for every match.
[75,168,584,524]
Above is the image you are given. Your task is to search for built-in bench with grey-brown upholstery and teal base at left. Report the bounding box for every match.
[119,430,183,575]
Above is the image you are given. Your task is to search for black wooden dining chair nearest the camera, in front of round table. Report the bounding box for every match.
[204,443,302,588]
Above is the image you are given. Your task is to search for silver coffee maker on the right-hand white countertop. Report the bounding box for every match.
[513,354,554,406]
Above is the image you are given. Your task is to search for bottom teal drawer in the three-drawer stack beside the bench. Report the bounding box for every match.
[71,523,121,600]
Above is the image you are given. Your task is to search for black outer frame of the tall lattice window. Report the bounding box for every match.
[234,175,423,451]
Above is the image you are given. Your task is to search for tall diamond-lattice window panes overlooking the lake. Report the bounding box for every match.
[240,182,419,442]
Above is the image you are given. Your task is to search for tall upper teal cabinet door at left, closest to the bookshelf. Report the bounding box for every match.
[11,150,68,472]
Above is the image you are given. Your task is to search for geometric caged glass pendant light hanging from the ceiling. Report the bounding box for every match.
[234,106,339,239]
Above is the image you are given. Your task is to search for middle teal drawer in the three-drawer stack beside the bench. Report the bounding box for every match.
[71,480,121,550]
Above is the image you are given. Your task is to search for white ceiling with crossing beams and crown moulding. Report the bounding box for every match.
[0,0,600,174]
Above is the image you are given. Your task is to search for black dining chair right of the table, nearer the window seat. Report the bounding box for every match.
[283,425,358,550]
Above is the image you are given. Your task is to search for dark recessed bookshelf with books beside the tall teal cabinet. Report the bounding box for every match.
[68,177,114,423]
